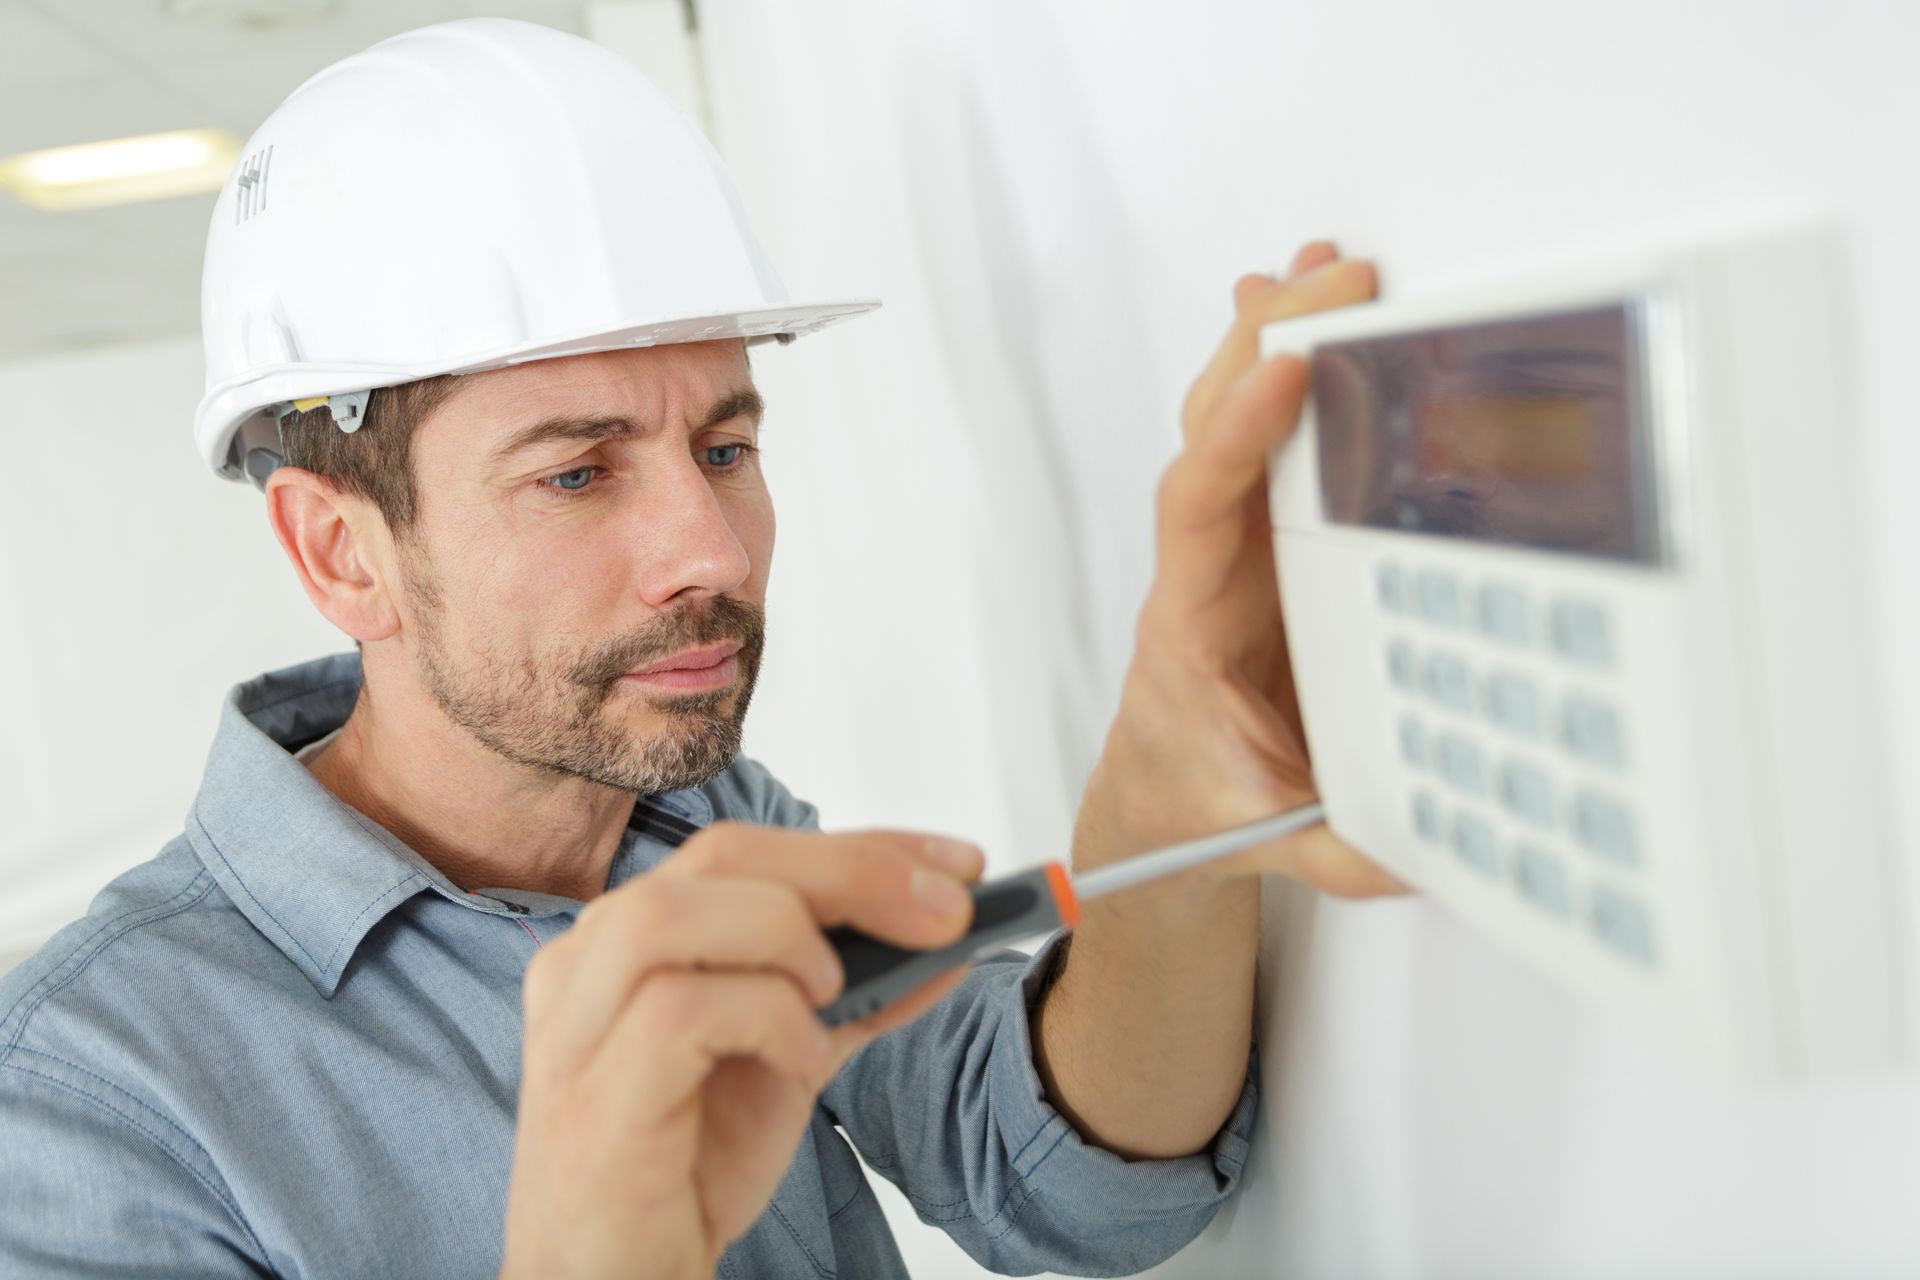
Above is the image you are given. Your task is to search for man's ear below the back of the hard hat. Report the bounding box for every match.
[267,466,399,643]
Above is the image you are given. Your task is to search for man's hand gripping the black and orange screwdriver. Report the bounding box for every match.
[501,821,981,1280]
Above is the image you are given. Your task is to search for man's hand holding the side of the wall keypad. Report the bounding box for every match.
[1073,242,1405,898]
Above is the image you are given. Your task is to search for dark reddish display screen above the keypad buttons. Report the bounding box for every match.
[1311,301,1661,564]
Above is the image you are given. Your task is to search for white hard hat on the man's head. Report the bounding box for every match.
[194,17,879,480]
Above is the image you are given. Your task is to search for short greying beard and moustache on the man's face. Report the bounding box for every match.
[407,562,766,794]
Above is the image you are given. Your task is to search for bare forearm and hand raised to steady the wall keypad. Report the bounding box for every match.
[1033,242,1405,1155]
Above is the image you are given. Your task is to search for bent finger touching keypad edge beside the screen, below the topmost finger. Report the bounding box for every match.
[1154,355,1308,618]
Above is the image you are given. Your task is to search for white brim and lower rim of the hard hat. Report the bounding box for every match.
[194,297,879,480]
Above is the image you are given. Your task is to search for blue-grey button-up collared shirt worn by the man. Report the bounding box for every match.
[0,654,1256,1280]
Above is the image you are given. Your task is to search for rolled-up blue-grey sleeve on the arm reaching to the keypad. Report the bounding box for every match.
[735,762,1260,1276]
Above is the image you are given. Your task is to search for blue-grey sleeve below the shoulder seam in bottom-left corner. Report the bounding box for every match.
[0,1046,273,1280]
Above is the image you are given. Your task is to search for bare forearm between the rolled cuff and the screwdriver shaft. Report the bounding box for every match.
[1035,752,1260,1157]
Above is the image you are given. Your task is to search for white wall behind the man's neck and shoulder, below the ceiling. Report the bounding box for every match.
[0,338,337,971]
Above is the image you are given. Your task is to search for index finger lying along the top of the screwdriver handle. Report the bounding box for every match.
[651,821,983,950]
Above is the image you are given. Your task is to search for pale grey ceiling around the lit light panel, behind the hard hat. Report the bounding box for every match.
[0,0,584,361]
